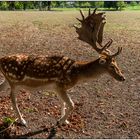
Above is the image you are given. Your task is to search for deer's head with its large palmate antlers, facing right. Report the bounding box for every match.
[74,9,125,81]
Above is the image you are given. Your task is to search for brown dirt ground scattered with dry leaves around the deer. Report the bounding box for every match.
[0,11,140,139]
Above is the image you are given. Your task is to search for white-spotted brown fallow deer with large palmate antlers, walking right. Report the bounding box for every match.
[0,10,125,125]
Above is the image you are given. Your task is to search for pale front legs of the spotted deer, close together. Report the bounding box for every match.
[58,90,74,124]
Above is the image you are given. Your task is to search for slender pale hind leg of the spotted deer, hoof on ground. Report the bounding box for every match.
[10,86,27,126]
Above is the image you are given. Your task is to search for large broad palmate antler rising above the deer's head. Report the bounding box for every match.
[74,8,120,53]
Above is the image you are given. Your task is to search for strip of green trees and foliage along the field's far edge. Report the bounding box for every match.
[0,1,140,11]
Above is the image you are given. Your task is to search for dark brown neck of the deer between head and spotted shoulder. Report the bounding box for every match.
[72,59,105,79]
